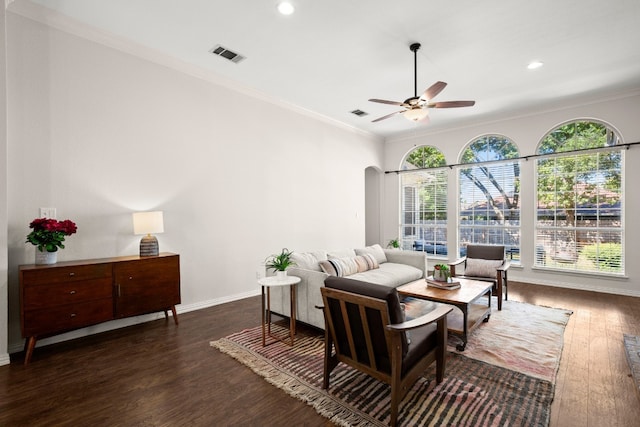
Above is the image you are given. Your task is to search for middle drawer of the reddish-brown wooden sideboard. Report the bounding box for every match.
[24,278,113,310]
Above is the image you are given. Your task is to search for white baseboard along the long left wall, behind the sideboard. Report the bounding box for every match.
[8,290,260,356]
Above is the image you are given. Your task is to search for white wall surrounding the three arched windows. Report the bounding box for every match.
[383,93,640,296]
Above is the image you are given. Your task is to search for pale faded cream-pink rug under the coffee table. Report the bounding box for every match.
[406,299,573,381]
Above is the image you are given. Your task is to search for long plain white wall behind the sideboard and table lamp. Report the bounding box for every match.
[0,13,382,351]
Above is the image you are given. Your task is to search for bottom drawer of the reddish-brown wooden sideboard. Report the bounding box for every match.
[23,298,113,336]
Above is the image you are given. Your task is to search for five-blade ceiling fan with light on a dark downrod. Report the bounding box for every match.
[369,43,476,123]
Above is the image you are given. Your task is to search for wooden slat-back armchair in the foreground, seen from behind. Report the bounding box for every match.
[320,277,452,426]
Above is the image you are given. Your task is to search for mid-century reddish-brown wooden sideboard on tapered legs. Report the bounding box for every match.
[19,253,180,365]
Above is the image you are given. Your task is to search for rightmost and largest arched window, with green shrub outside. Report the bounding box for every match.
[535,120,624,274]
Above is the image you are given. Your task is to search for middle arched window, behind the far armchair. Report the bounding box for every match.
[458,135,520,263]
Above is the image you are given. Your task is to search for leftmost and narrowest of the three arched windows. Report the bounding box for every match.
[400,146,447,256]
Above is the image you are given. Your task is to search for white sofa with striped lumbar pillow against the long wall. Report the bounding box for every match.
[270,245,427,329]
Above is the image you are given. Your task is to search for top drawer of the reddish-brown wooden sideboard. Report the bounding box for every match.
[22,263,113,285]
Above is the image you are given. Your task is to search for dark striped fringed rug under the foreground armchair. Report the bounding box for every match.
[211,327,554,427]
